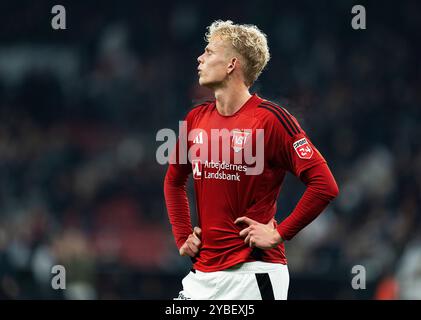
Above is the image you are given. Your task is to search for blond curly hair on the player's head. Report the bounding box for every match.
[205,20,270,86]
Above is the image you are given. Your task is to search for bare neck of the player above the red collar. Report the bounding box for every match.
[215,87,251,116]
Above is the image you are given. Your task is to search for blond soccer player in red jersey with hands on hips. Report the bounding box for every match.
[164,21,338,300]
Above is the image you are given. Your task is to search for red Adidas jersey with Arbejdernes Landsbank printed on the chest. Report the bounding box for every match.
[166,94,325,272]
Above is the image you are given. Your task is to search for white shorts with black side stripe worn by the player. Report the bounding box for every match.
[175,261,289,300]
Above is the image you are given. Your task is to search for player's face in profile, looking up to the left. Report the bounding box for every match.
[197,37,231,88]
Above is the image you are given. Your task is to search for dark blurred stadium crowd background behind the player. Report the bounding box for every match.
[0,1,421,299]
